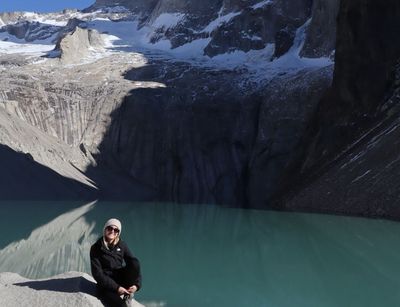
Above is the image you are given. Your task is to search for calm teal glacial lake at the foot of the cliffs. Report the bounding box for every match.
[0,202,400,307]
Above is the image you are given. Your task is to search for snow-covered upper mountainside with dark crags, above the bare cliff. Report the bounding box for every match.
[0,0,334,65]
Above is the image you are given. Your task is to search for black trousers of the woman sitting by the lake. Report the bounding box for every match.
[97,264,138,307]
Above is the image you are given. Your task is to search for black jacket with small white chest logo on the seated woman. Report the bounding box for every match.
[90,238,141,291]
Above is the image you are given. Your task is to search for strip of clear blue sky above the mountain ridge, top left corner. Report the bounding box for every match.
[0,0,95,12]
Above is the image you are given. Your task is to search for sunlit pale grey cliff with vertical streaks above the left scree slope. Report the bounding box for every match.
[0,55,144,152]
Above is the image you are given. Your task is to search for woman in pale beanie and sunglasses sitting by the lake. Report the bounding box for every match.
[90,218,141,307]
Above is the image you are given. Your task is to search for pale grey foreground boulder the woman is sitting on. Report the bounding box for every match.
[0,272,163,307]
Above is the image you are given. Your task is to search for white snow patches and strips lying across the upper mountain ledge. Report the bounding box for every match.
[0,10,333,79]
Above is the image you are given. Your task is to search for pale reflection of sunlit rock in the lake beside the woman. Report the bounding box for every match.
[0,203,96,278]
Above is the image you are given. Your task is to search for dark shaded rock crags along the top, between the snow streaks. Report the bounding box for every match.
[89,0,319,57]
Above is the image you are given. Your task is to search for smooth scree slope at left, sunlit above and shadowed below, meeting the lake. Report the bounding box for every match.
[0,101,95,200]
